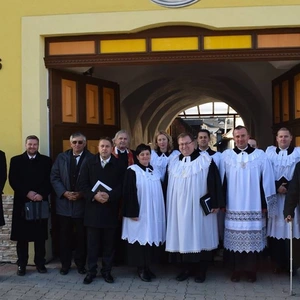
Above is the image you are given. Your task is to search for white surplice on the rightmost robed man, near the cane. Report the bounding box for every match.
[266,146,300,239]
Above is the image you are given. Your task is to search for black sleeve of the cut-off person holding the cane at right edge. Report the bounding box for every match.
[283,163,300,218]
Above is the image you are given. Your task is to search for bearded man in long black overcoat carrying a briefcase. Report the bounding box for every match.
[9,135,52,276]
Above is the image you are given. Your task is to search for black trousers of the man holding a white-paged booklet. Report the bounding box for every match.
[87,227,117,275]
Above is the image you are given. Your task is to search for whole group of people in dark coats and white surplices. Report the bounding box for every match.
[0,126,300,284]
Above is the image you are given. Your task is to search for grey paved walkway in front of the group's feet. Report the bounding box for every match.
[0,262,300,300]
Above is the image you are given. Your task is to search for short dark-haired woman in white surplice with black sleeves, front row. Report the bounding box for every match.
[122,144,166,282]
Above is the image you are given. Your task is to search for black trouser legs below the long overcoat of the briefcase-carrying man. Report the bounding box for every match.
[17,239,46,267]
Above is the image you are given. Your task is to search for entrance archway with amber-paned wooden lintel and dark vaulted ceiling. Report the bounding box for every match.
[45,26,300,147]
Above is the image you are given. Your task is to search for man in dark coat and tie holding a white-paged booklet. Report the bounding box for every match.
[79,137,126,284]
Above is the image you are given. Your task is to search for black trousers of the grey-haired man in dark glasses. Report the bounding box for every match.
[58,215,86,269]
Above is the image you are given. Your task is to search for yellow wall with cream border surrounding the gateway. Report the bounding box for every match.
[0,0,300,193]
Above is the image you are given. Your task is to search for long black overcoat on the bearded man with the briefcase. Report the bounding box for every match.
[9,152,52,241]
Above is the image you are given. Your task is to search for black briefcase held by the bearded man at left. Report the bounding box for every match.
[25,201,50,221]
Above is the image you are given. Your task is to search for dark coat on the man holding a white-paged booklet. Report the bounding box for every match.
[79,154,126,228]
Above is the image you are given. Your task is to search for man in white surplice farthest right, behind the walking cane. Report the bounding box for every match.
[266,128,300,273]
